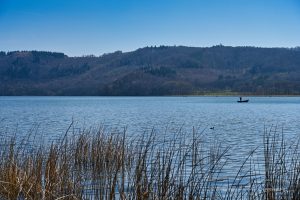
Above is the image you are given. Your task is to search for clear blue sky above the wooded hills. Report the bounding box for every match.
[0,0,300,56]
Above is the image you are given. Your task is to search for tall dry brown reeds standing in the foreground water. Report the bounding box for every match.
[0,128,300,200]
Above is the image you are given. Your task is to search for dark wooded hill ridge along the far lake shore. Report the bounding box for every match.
[0,45,300,95]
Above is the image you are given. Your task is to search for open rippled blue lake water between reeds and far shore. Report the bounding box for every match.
[0,97,300,149]
